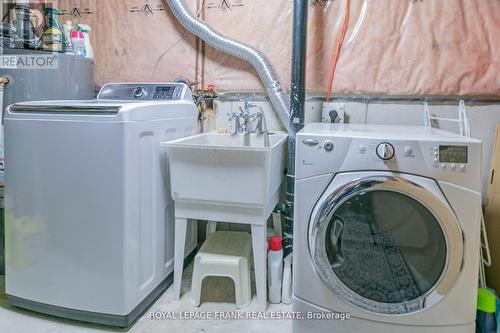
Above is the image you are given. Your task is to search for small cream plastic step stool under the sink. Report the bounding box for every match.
[191,231,252,309]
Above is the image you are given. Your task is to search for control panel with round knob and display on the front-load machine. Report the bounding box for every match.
[295,125,482,192]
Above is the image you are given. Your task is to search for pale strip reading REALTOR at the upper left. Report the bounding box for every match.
[0,54,59,69]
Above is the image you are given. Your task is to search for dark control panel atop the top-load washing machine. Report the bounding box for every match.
[97,83,189,101]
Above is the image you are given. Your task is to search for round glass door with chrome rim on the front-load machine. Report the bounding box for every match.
[309,173,463,314]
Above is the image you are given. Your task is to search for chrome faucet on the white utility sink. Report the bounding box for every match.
[228,100,269,147]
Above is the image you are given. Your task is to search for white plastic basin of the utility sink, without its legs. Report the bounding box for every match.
[161,132,288,210]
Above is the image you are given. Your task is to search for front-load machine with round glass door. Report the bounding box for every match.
[293,124,481,333]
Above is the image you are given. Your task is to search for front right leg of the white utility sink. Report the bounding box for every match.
[252,224,267,311]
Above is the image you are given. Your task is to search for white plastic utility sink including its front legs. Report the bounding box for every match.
[162,132,288,311]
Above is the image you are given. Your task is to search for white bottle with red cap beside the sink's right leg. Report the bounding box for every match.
[267,236,283,303]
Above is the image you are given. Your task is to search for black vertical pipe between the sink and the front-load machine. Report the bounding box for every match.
[283,0,309,253]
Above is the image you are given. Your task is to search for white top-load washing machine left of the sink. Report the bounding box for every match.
[5,83,197,326]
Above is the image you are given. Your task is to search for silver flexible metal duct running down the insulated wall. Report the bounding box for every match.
[165,0,290,130]
